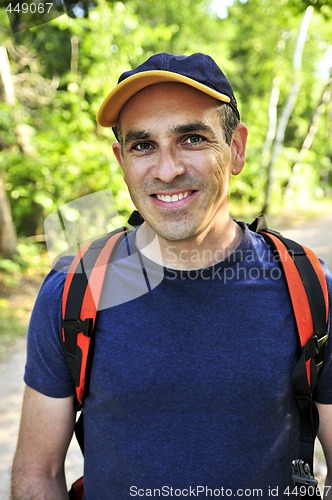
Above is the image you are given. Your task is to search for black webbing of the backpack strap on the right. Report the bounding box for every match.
[249,218,328,499]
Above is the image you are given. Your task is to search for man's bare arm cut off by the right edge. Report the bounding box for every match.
[316,403,332,500]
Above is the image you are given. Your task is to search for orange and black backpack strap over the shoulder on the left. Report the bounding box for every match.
[62,228,128,410]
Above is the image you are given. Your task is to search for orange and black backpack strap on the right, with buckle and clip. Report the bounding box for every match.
[249,218,329,498]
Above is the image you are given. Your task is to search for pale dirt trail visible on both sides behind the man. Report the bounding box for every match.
[0,214,332,500]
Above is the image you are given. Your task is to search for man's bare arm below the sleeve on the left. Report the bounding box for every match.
[11,387,75,500]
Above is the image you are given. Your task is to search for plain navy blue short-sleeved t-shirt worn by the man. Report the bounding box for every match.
[25,226,332,500]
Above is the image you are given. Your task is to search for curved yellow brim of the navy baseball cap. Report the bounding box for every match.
[97,70,230,127]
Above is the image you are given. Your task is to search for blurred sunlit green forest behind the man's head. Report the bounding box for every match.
[0,0,332,286]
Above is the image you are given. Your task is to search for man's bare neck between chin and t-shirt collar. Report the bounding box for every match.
[136,218,243,270]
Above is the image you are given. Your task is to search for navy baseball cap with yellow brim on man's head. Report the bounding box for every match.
[97,52,240,127]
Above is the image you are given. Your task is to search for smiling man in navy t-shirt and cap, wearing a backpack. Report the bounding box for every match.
[12,54,332,500]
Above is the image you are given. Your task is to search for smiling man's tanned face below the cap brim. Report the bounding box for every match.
[113,83,246,241]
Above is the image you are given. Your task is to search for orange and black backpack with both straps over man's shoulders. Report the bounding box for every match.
[62,216,329,499]
